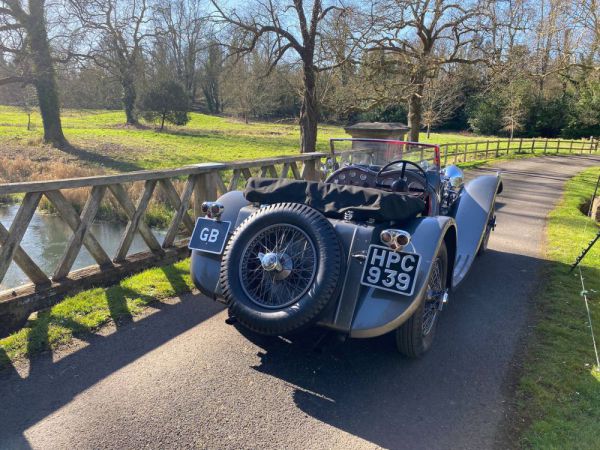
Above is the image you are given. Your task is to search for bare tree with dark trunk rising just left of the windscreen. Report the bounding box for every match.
[211,0,356,152]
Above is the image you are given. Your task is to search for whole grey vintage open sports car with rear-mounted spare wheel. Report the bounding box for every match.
[190,139,502,357]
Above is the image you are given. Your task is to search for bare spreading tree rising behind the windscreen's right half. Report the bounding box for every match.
[369,0,482,142]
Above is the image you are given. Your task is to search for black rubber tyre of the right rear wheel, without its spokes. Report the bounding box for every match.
[396,242,448,358]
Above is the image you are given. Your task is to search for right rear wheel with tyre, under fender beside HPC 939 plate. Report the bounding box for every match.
[396,242,448,358]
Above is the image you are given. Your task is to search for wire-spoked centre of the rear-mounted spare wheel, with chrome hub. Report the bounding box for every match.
[239,224,317,309]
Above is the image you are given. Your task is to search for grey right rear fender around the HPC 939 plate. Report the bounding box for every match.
[340,216,455,338]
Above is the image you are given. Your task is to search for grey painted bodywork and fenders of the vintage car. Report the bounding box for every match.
[191,139,502,338]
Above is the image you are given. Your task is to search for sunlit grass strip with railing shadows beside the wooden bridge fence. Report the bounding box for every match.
[0,259,192,370]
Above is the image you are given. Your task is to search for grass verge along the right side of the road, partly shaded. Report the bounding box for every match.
[518,167,600,449]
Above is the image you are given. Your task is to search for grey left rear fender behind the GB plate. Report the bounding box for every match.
[191,191,249,300]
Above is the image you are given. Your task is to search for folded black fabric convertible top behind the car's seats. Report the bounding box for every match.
[244,178,425,222]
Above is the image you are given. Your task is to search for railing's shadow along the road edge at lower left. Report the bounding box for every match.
[0,290,223,449]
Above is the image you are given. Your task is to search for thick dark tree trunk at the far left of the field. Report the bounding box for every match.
[26,0,67,147]
